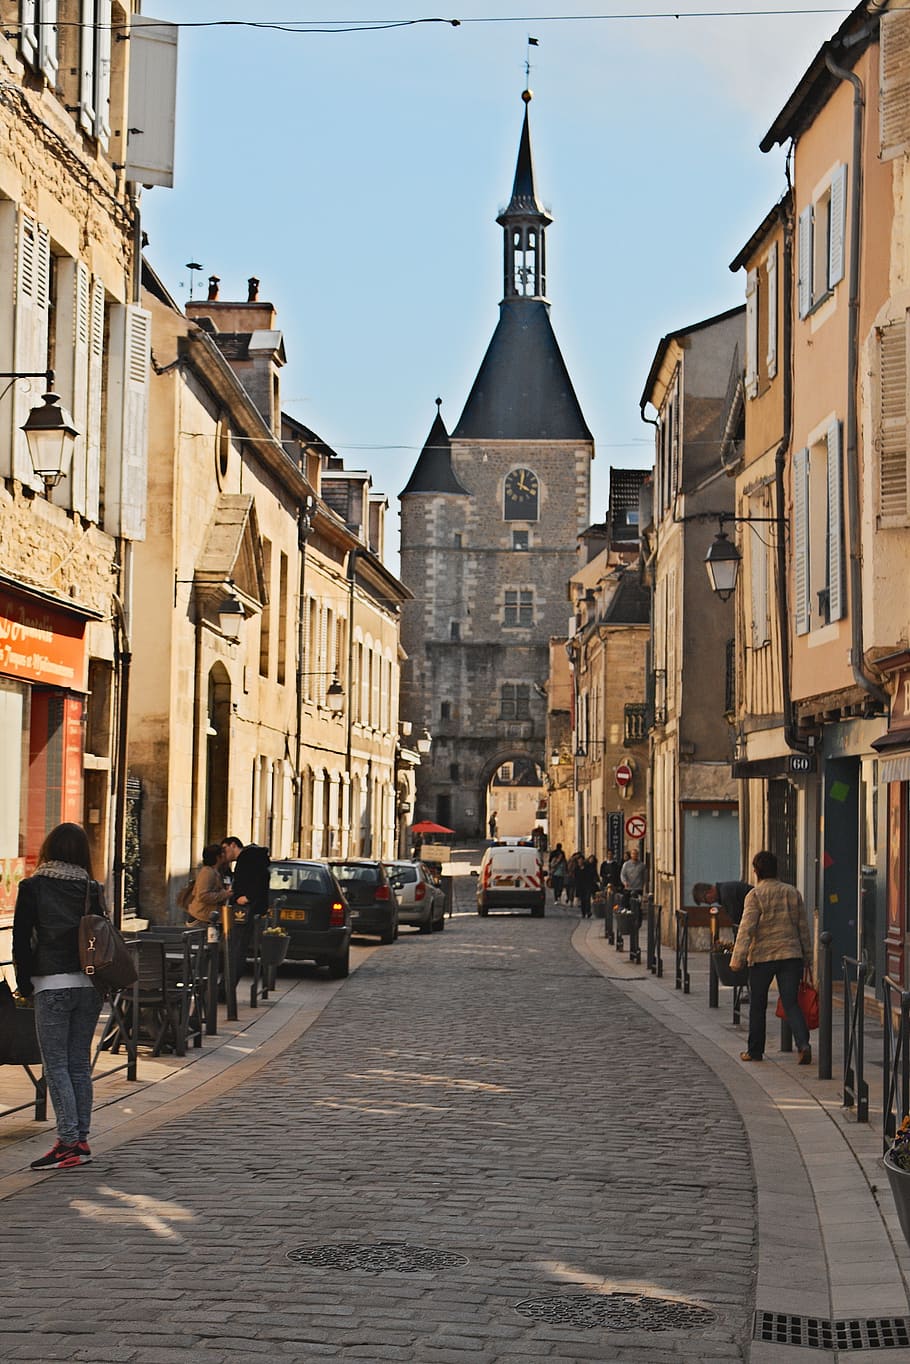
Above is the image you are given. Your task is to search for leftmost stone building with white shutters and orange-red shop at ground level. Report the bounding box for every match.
[0,0,176,925]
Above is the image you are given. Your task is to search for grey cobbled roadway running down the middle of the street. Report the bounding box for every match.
[0,883,756,1364]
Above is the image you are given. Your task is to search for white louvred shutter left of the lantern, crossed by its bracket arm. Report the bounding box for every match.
[12,214,50,488]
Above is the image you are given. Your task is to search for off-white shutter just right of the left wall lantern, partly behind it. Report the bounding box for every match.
[53,258,90,516]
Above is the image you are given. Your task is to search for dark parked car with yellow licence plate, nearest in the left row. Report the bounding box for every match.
[269,858,351,979]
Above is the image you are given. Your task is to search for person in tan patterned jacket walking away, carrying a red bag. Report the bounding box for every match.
[730,851,812,1065]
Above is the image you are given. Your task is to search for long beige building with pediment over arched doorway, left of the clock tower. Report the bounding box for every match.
[130,270,405,919]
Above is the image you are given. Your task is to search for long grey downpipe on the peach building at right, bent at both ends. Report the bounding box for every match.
[824,43,888,711]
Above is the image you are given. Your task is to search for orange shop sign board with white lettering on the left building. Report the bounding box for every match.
[0,591,85,692]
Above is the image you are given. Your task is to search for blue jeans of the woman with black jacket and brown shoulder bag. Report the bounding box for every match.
[34,986,102,1146]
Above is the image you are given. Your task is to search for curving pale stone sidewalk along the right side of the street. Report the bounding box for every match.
[573,910,910,1364]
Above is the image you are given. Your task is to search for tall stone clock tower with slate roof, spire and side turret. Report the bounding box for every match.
[401,90,593,837]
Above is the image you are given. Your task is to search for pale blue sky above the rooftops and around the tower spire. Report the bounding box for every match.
[141,0,853,569]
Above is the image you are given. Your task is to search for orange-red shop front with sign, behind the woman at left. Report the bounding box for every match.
[0,585,86,926]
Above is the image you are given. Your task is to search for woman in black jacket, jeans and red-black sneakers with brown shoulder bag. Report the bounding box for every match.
[12,824,104,1170]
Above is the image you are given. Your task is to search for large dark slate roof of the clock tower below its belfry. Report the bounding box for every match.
[452,299,593,441]
